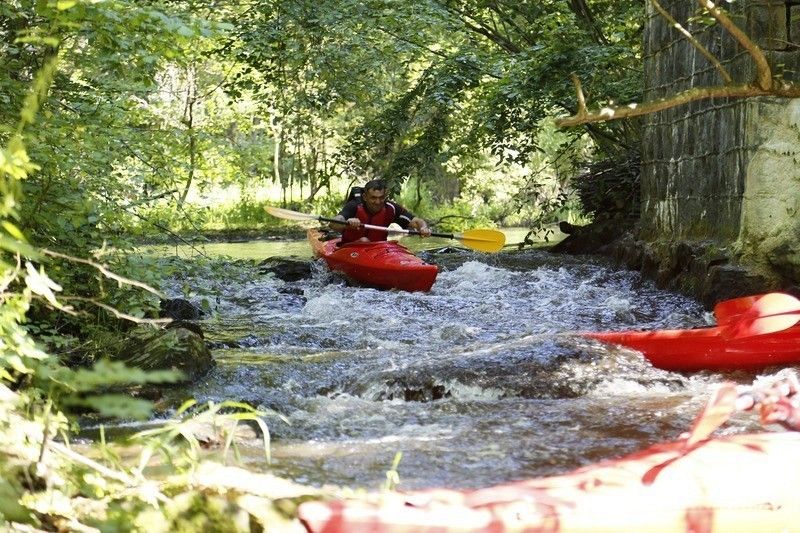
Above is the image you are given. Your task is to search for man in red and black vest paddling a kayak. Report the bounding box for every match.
[334,180,431,244]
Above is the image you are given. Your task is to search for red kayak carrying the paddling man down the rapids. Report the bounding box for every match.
[308,229,439,292]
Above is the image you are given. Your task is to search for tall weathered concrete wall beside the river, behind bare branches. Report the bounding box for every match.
[640,0,800,281]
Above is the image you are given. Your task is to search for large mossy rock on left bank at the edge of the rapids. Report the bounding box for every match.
[117,327,214,382]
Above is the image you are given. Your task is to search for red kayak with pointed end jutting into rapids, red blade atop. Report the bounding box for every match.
[582,293,800,371]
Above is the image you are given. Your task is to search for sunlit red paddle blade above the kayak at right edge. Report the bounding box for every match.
[722,292,800,339]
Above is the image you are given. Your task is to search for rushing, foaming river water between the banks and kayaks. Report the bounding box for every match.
[147,233,772,489]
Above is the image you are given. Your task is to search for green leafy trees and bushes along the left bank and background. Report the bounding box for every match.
[0,0,656,531]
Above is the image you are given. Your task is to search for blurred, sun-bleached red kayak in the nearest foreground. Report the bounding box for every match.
[298,376,800,533]
